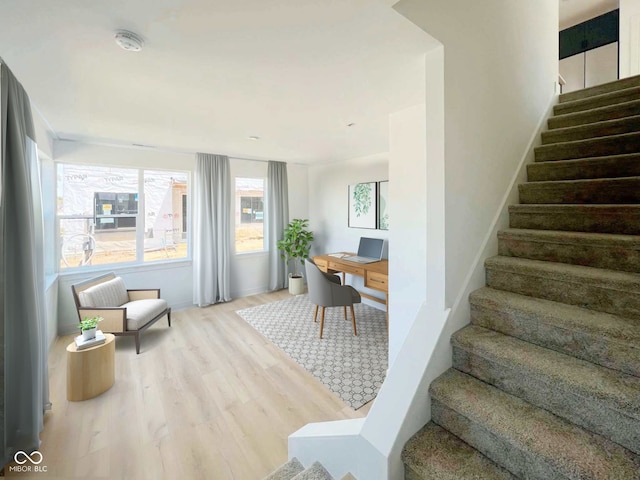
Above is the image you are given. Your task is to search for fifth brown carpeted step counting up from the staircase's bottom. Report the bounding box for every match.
[485,256,640,325]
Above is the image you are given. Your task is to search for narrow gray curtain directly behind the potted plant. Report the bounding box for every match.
[267,161,289,290]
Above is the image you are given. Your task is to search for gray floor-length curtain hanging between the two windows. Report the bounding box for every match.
[193,153,231,307]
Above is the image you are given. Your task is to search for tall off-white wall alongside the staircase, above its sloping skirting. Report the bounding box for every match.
[394,0,558,306]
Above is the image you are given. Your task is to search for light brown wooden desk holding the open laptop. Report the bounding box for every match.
[313,252,389,317]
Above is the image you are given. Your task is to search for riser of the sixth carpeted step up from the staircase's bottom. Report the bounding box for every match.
[498,234,640,273]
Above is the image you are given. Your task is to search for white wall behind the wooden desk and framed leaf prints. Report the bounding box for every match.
[306,153,394,309]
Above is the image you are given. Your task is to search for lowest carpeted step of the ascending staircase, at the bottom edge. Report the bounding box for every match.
[402,422,515,480]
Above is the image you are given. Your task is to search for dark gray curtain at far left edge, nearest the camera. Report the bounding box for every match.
[0,59,51,465]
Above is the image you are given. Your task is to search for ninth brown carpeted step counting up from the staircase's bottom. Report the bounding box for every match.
[527,153,640,182]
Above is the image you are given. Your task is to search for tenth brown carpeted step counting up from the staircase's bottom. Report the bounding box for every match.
[534,132,640,162]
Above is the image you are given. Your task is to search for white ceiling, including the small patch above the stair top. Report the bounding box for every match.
[0,0,617,163]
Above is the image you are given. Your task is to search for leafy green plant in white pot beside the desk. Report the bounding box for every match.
[278,218,313,295]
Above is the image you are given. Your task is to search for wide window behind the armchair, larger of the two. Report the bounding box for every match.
[57,164,188,269]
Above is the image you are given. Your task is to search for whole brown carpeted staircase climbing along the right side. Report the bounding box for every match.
[403,76,640,480]
